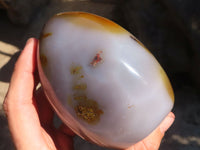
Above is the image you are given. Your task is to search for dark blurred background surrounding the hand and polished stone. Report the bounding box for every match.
[0,0,200,150]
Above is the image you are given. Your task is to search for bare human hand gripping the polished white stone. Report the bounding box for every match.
[4,38,175,150]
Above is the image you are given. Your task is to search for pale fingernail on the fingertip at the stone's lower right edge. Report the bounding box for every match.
[160,112,175,134]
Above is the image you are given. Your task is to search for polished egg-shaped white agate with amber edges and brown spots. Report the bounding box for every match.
[38,12,174,149]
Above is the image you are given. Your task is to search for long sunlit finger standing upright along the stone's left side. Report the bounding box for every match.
[4,39,45,149]
